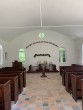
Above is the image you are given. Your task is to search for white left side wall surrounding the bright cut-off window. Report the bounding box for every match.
[0,39,8,68]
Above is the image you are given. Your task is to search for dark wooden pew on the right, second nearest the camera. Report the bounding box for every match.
[71,74,83,101]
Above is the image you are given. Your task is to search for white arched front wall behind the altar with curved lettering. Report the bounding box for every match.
[8,30,76,68]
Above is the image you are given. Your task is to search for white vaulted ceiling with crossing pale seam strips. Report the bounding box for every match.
[0,0,83,41]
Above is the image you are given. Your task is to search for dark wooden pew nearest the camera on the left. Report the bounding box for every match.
[0,80,11,110]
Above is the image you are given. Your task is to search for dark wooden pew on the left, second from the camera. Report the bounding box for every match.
[0,75,18,103]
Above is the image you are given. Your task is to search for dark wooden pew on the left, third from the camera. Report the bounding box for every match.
[0,71,23,94]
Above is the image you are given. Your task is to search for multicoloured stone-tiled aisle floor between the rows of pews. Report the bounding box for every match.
[13,73,82,110]
